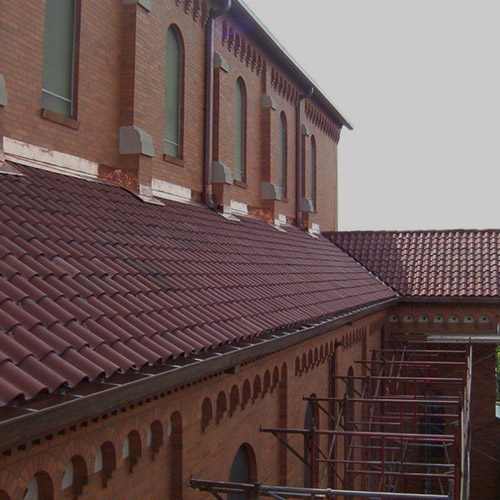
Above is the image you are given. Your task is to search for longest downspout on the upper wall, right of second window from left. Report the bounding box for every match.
[203,0,232,210]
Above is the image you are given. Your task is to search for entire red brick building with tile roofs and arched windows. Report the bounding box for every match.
[0,0,500,500]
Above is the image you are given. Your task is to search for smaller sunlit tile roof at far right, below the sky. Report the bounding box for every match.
[330,230,500,297]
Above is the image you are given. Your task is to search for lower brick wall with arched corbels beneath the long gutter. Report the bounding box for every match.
[0,313,384,500]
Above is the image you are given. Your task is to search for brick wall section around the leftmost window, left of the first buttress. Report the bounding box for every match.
[0,0,122,165]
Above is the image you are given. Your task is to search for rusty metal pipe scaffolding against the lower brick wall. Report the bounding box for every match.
[191,335,498,500]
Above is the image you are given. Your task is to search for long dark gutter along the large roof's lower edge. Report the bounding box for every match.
[0,298,398,452]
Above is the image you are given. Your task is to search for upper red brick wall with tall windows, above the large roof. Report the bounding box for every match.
[0,0,344,230]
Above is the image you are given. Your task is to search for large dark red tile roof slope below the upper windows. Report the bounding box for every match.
[0,166,394,406]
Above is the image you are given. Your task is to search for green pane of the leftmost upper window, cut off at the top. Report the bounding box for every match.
[42,0,76,116]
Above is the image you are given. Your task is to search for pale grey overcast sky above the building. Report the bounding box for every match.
[246,0,500,230]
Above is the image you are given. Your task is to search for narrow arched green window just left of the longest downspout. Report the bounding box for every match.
[163,28,182,158]
